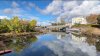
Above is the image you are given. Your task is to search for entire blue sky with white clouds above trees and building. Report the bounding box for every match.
[0,0,100,25]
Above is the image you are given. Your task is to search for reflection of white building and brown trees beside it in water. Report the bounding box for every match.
[72,35,100,51]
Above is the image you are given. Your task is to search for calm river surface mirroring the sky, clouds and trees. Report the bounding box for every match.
[0,32,100,56]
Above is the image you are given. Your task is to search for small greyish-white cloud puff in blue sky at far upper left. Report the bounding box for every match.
[2,1,23,16]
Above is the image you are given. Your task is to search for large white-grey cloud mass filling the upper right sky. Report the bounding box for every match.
[35,0,100,20]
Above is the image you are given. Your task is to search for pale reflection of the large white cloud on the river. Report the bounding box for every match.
[44,32,96,56]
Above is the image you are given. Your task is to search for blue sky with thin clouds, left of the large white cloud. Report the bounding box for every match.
[0,0,56,25]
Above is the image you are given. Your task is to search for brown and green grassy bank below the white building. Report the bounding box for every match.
[72,25,100,36]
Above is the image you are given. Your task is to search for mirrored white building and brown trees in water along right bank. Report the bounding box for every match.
[72,34,100,52]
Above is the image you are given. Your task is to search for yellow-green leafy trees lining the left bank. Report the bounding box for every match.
[0,16,37,33]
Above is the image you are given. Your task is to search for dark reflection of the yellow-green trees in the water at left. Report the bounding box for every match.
[0,36,37,52]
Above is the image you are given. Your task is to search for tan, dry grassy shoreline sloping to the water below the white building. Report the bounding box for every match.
[74,26,100,37]
